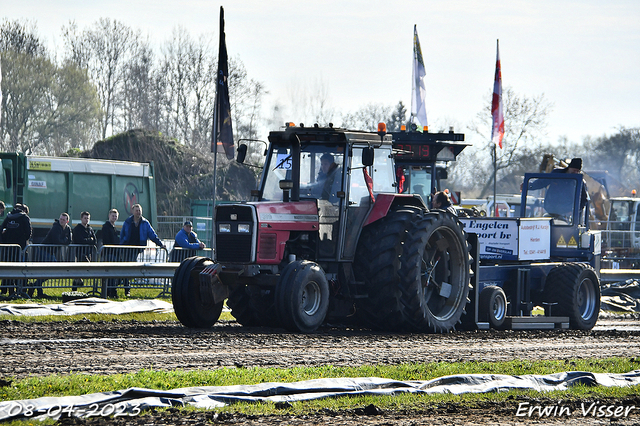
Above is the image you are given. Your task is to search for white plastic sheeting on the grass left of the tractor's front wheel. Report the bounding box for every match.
[0,297,173,316]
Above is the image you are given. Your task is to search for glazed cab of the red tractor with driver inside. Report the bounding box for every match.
[258,126,395,260]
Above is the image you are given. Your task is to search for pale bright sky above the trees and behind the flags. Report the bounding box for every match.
[0,0,640,146]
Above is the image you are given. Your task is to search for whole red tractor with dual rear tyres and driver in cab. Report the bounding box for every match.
[172,126,470,333]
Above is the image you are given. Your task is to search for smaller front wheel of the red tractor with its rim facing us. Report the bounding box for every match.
[276,260,329,333]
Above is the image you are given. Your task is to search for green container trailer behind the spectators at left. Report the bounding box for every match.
[0,153,157,243]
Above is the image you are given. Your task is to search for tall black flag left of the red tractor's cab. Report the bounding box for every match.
[211,6,234,160]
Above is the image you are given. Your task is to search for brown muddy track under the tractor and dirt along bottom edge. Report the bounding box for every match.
[0,316,640,425]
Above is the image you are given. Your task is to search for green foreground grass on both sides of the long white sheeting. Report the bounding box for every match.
[0,358,640,414]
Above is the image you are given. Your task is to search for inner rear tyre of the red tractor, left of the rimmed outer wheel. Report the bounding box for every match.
[353,207,422,331]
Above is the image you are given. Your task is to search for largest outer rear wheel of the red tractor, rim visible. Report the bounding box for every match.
[399,211,471,333]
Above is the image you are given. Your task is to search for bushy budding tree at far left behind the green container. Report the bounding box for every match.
[0,21,100,154]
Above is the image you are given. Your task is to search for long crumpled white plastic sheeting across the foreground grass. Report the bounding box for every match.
[0,370,640,421]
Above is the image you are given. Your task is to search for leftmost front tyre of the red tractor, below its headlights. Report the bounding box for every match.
[171,257,224,328]
